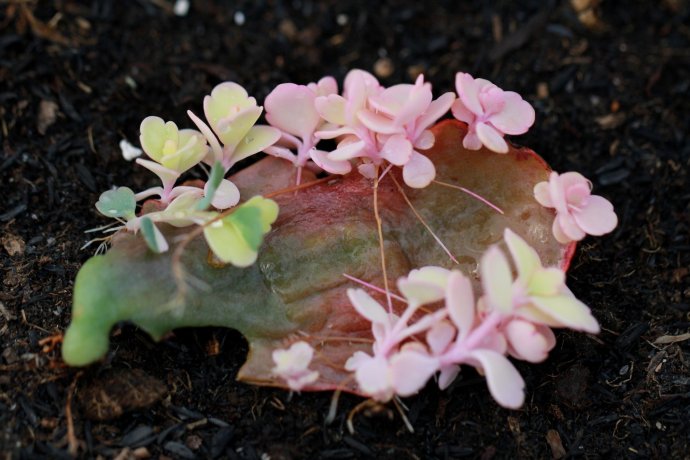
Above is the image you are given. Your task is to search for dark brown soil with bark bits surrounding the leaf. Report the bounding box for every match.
[0,0,690,459]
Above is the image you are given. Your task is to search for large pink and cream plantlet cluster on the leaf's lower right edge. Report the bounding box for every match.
[345,229,599,408]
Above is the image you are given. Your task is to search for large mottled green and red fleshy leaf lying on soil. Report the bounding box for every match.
[63,122,574,391]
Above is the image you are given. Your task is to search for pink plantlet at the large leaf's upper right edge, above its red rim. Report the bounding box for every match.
[451,72,535,153]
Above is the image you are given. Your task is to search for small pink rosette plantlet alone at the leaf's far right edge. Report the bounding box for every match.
[534,172,618,244]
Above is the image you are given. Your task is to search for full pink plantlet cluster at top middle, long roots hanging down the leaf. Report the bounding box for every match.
[316,70,455,188]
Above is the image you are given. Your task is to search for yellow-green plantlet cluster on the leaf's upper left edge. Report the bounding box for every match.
[96,83,279,267]
